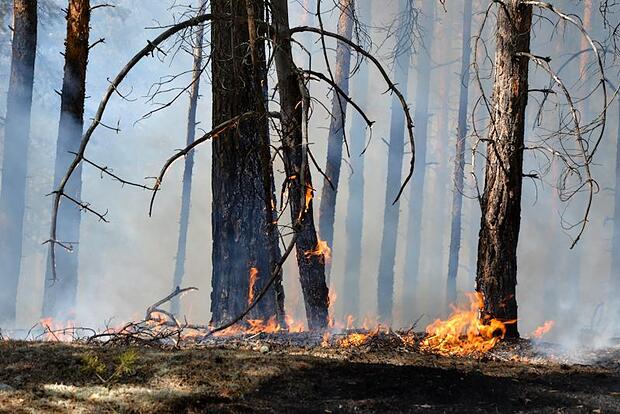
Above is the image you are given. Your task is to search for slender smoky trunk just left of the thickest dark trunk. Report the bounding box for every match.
[170,0,204,315]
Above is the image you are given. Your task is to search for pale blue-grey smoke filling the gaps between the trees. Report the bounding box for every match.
[0,0,620,342]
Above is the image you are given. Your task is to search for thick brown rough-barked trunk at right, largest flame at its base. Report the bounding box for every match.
[476,0,532,337]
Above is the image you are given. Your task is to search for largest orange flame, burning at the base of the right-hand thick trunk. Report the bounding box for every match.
[420,292,514,356]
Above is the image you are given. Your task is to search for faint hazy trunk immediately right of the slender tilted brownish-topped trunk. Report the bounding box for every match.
[344,0,372,318]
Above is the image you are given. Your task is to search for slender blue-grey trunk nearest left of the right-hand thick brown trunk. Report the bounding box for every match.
[446,0,472,304]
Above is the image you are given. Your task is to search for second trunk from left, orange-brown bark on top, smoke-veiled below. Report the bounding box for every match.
[43,0,90,320]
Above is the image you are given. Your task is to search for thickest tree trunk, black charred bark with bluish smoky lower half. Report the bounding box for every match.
[211,0,284,325]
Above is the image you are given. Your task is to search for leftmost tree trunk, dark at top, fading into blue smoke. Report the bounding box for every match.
[0,0,37,324]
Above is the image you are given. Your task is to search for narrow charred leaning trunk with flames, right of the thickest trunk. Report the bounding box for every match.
[271,0,329,330]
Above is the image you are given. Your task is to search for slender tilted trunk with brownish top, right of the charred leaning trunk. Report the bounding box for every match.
[319,0,355,285]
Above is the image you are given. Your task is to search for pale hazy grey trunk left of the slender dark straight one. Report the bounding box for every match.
[403,2,435,303]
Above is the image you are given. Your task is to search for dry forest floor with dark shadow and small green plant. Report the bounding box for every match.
[0,337,620,413]
